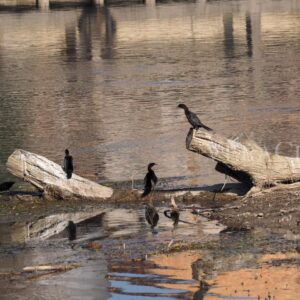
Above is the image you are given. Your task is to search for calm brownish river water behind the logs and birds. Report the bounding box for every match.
[0,0,300,188]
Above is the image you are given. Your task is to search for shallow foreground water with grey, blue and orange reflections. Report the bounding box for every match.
[0,207,299,300]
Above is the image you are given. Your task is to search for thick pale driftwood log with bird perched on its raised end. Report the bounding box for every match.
[186,129,300,187]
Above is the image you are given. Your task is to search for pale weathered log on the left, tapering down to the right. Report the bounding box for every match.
[6,149,113,200]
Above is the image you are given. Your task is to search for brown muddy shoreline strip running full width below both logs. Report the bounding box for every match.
[0,183,300,235]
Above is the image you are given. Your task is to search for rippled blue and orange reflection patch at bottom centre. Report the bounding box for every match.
[109,252,200,299]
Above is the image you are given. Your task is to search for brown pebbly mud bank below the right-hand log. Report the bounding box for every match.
[209,190,300,233]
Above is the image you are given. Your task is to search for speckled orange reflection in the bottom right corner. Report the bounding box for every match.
[205,253,300,300]
